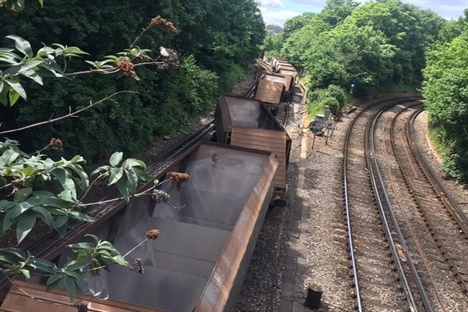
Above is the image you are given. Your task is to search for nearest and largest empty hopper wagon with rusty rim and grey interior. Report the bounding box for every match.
[0,142,278,312]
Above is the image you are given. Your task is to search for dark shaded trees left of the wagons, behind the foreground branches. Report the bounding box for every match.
[0,0,265,162]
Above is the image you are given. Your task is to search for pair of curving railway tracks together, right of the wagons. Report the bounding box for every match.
[336,96,468,312]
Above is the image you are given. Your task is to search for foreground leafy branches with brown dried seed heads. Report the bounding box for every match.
[0,0,185,301]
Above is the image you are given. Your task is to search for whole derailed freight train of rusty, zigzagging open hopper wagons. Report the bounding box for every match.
[0,58,296,312]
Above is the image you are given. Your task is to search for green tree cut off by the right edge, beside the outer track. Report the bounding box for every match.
[422,30,468,182]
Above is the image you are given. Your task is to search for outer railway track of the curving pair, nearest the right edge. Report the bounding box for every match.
[381,105,468,311]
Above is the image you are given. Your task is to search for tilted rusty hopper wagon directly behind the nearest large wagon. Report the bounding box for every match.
[215,96,291,190]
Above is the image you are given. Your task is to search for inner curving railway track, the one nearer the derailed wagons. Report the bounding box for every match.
[343,98,422,312]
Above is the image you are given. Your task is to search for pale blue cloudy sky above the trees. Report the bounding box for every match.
[257,0,468,26]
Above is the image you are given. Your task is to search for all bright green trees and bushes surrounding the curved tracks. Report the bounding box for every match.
[264,0,468,181]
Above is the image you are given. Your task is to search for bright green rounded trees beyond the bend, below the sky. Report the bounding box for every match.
[266,0,446,96]
